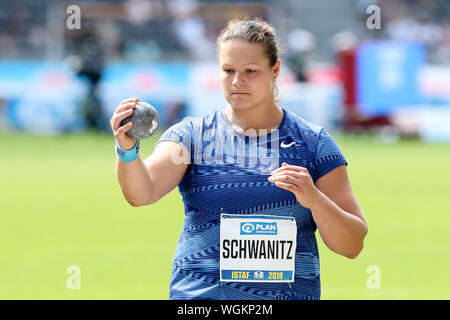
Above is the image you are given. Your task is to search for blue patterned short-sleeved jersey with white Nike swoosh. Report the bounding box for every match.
[157,108,347,300]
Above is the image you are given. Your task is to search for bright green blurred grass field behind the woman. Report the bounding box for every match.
[0,133,450,299]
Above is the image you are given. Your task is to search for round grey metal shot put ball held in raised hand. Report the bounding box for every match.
[121,102,159,139]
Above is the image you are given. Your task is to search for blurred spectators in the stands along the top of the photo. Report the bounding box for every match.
[0,0,450,63]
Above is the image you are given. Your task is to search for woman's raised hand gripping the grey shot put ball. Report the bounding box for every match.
[109,98,139,150]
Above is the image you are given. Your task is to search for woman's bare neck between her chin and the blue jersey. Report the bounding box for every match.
[224,103,283,135]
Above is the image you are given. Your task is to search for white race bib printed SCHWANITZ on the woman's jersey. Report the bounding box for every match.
[220,213,297,282]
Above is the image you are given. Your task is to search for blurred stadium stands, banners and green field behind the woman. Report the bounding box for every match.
[0,0,450,299]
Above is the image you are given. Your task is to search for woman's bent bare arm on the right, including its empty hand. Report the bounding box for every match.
[269,163,368,259]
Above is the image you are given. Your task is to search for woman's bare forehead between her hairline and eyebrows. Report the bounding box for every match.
[219,40,269,67]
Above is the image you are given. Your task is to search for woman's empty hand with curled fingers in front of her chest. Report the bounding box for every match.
[267,162,321,209]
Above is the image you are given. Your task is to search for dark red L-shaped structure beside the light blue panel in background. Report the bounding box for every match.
[337,48,391,131]
